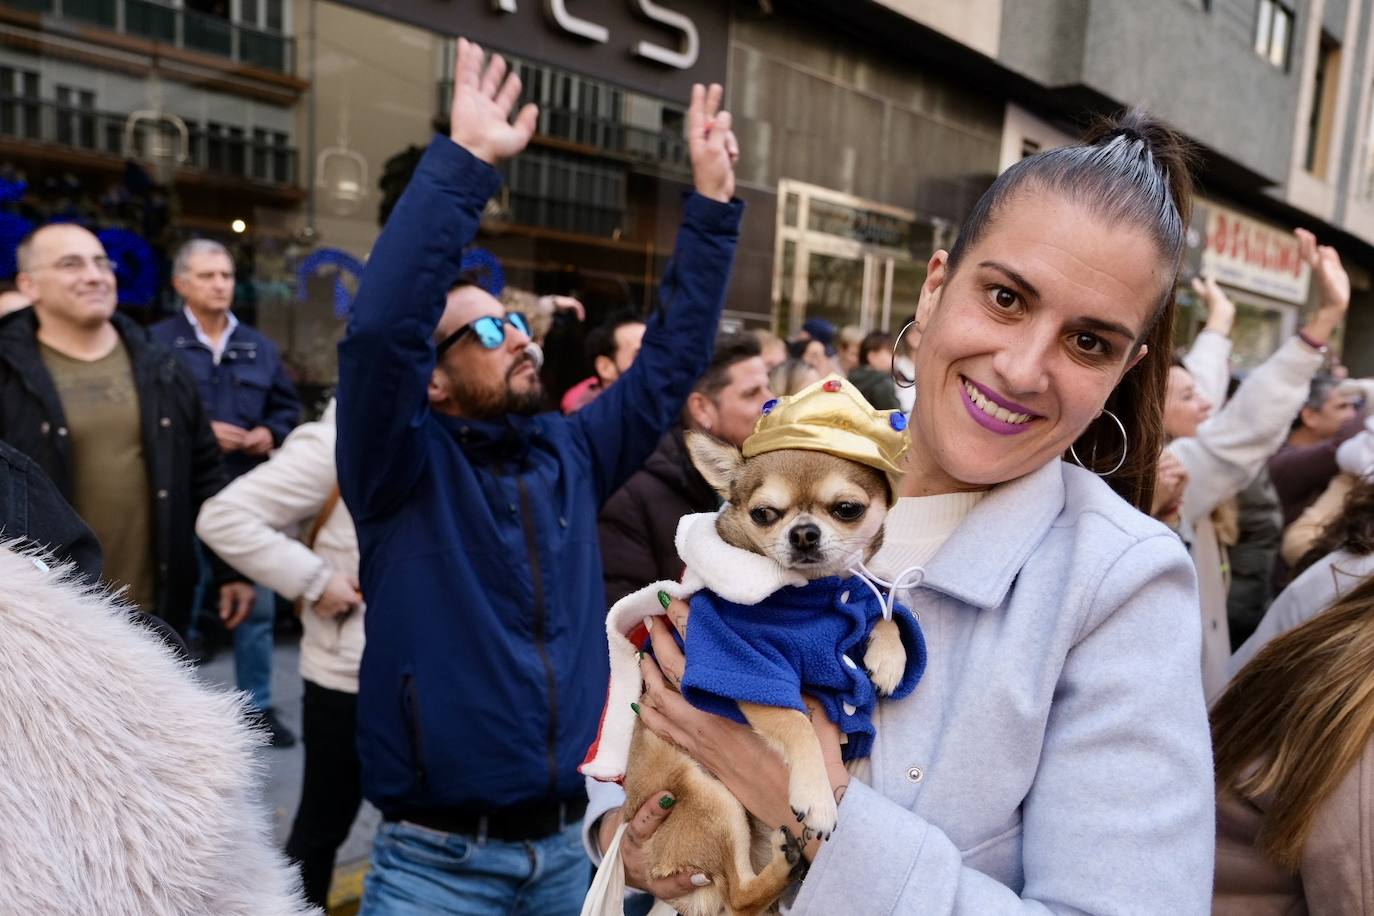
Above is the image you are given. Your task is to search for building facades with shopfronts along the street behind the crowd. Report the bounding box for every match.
[0,0,1374,386]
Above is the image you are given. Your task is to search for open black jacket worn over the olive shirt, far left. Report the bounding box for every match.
[0,309,231,633]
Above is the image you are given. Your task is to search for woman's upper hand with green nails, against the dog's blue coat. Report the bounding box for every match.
[640,600,849,858]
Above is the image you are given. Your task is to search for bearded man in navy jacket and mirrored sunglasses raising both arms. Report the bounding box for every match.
[338,40,742,916]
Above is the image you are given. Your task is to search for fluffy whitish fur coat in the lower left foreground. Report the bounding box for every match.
[0,544,319,916]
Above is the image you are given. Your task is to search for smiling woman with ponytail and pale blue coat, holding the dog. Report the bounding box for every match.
[587,114,1225,915]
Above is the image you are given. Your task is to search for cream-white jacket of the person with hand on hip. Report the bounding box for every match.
[195,401,364,694]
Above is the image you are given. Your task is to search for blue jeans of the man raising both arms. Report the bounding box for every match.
[359,821,592,916]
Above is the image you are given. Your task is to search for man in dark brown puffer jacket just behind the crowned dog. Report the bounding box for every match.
[598,334,772,604]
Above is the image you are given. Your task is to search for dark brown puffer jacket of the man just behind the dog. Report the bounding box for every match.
[598,428,720,607]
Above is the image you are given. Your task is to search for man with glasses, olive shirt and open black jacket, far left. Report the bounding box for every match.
[0,224,241,634]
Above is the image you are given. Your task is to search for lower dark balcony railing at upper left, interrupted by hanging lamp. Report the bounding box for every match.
[0,93,297,185]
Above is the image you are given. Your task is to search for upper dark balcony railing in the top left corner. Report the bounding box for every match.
[5,0,295,73]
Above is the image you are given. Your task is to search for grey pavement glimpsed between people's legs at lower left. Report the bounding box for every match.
[201,637,381,915]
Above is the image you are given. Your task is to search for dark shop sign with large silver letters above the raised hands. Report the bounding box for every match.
[336,0,730,102]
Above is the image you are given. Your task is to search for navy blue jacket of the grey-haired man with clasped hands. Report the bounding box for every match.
[148,312,301,477]
